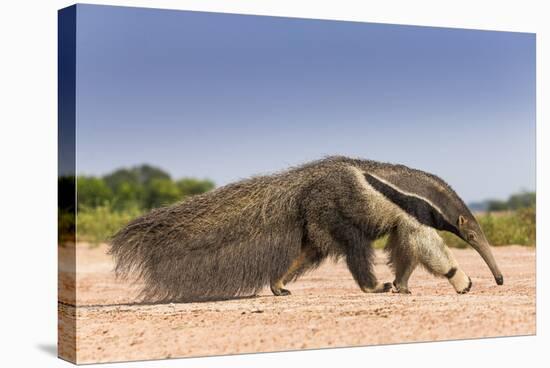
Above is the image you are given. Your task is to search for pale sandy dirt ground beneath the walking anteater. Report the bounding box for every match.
[58,244,536,363]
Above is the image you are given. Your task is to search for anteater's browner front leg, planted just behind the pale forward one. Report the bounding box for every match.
[385,229,418,294]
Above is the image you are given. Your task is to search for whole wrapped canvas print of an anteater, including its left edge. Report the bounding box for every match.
[58,5,536,363]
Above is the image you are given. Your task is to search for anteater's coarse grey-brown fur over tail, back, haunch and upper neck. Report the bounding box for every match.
[110,157,500,302]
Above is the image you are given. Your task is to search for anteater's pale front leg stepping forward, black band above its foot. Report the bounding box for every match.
[410,226,472,294]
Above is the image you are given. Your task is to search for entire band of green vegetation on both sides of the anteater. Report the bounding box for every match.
[58,165,536,248]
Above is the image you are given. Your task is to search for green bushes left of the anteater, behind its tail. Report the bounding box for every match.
[58,165,215,243]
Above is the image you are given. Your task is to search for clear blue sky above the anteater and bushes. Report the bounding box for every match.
[71,5,535,202]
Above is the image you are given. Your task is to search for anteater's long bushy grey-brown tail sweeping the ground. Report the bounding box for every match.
[109,203,302,302]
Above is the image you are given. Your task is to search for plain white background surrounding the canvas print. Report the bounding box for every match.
[0,0,550,368]
